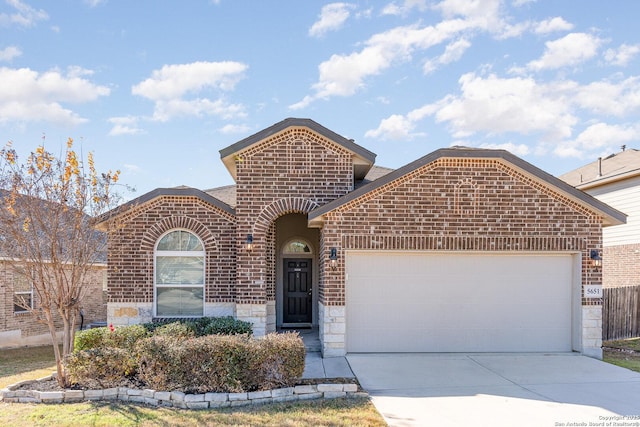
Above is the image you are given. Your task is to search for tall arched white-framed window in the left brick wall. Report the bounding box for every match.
[154,230,205,317]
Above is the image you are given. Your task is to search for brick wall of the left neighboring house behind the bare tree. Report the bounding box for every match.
[0,264,107,348]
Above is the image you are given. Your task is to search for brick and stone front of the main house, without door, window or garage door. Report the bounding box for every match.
[102,119,620,357]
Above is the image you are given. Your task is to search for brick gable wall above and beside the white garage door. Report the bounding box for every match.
[320,159,602,305]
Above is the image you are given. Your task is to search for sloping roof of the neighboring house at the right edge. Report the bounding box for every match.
[560,149,640,190]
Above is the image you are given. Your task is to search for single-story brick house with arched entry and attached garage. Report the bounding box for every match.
[103,118,625,357]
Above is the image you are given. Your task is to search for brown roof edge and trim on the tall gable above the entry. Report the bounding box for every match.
[220,117,376,180]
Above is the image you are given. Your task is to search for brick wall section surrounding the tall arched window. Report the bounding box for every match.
[107,196,238,324]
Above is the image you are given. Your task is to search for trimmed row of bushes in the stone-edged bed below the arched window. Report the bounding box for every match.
[65,317,305,393]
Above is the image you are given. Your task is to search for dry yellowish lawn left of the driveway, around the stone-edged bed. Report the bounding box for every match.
[0,346,386,427]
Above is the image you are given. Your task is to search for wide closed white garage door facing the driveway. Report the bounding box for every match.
[346,252,573,352]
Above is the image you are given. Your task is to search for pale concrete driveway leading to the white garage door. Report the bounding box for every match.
[347,353,640,427]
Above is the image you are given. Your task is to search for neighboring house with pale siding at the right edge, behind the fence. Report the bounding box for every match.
[560,149,640,287]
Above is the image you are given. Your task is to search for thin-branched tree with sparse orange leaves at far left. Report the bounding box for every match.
[0,138,124,386]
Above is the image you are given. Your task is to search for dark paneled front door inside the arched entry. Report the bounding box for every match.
[283,258,312,323]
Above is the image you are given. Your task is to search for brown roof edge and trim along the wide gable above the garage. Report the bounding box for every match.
[308,147,627,226]
